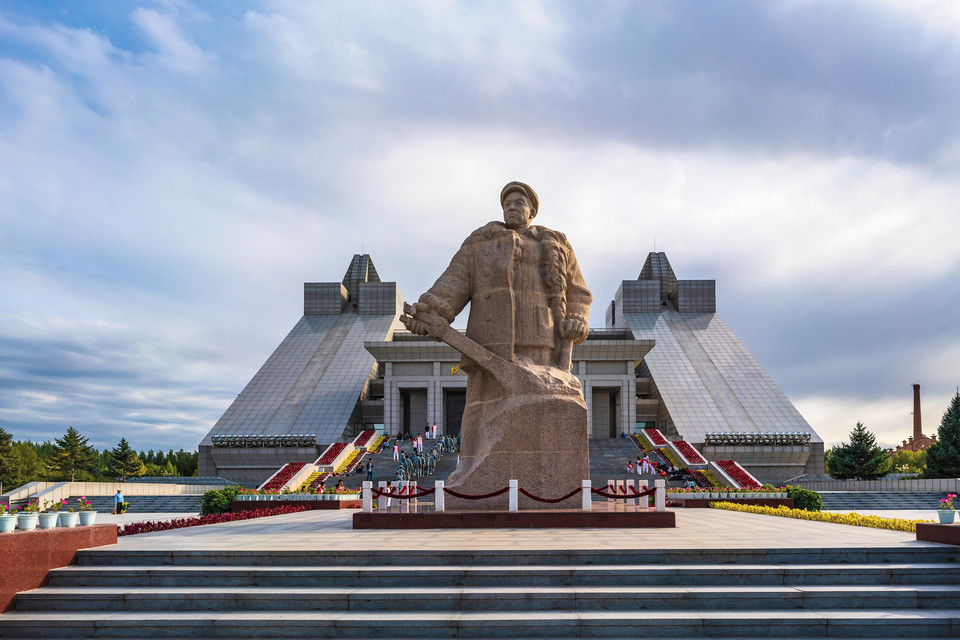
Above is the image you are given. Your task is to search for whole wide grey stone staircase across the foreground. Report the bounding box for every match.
[0,546,960,639]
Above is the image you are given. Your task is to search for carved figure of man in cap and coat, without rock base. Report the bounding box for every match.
[408,182,593,373]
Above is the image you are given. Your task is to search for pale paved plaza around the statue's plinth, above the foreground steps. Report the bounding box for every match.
[101,509,942,550]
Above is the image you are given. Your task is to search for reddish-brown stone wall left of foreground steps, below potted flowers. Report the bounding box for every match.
[0,524,117,612]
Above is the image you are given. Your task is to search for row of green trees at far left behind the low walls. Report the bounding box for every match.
[0,427,198,489]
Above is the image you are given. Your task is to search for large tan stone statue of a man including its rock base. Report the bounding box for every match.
[401,182,592,509]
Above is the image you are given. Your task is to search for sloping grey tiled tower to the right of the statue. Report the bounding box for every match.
[606,252,823,482]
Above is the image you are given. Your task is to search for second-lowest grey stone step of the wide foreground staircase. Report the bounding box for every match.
[17,585,960,613]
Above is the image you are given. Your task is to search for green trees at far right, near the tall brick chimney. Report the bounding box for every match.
[825,391,960,480]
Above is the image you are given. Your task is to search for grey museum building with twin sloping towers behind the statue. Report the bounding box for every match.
[199,252,823,484]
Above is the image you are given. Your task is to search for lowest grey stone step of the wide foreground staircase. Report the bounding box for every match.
[0,608,960,639]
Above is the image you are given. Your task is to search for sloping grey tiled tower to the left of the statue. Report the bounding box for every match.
[199,254,403,484]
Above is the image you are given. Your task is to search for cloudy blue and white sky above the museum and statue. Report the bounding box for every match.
[0,0,960,449]
